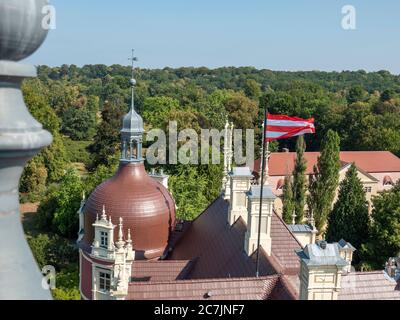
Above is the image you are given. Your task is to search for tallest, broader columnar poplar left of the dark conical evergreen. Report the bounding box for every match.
[307,130,340,234]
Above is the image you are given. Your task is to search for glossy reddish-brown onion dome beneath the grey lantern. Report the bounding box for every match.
[83,163,175,259]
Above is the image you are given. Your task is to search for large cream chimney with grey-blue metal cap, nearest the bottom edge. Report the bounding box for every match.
[296,241,348,300]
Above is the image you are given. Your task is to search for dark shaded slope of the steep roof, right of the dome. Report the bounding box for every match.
[168,197,276,279]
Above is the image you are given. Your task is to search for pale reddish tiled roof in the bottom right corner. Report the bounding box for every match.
[339,271,400,300]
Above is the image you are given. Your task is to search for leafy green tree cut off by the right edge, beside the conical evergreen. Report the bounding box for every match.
[360,180,400,270]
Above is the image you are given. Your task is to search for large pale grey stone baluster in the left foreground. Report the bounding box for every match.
[0,0,52,300]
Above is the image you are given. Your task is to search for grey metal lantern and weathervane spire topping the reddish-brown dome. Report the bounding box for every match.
[121,50,144,162]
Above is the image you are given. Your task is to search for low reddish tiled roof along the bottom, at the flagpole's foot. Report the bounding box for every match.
[128,275,282,300]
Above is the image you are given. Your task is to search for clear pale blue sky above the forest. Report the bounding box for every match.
[28,0,400,74]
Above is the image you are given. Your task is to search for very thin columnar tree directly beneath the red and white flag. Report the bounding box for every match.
[293,136,307,224]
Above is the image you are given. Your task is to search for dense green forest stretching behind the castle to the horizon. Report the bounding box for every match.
[20,65,400,299]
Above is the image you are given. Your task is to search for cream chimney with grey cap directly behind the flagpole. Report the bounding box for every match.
[244,185,276,256]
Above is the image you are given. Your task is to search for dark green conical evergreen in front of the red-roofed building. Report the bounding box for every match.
[326,164,369,263]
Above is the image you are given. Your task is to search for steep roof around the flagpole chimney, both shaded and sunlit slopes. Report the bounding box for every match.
[168,198,302,279]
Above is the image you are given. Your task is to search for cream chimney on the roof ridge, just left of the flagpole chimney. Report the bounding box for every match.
[228,167,253,225]
